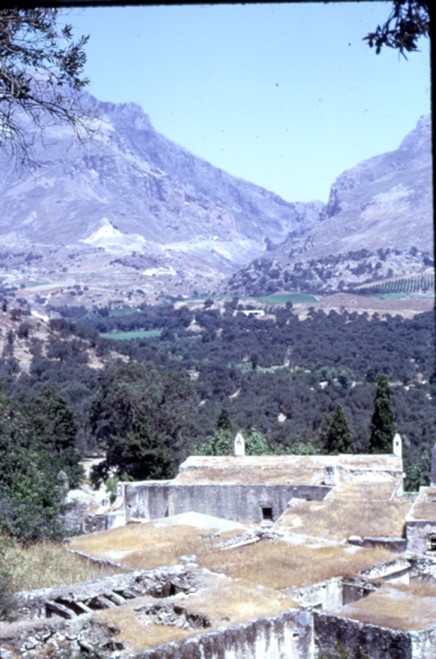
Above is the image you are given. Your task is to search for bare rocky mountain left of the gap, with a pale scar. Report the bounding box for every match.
[0,92,323,300]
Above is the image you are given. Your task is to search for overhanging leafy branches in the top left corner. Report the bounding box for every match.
[0,7,88,162]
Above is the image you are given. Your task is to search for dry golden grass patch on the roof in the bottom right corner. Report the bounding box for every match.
[341,583,436,630]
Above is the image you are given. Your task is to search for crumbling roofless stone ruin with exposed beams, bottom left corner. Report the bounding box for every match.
[0,563,210,659]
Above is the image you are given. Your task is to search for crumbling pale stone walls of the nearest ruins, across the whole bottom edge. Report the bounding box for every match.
[0,557,436,659]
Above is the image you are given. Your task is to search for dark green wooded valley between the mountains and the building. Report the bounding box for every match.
[0,298,436,528]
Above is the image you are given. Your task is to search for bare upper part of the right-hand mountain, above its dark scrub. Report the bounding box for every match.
[312,116,433,256]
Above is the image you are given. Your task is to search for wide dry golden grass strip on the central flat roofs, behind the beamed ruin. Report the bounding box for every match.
[72,523,392,590]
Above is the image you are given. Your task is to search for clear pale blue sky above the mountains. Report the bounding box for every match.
[67,0,431,202]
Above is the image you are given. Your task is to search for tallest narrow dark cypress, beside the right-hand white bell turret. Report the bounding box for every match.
[369,374,395,453]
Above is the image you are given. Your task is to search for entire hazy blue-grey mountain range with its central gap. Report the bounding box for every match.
[0,91,433,304]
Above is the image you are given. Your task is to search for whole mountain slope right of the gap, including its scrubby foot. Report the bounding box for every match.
[225,116,433,293]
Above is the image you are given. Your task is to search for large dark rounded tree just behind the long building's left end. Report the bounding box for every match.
[91,362,197,483]
